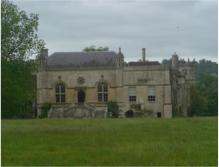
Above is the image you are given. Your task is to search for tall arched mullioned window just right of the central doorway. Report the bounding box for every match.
[97,82,108,102]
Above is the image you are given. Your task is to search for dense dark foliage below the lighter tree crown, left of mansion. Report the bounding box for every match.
[2,60,34,118]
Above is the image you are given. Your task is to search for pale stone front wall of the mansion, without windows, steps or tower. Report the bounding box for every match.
[37,65,172,117]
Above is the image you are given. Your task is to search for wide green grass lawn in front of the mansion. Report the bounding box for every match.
[1,117,218,166]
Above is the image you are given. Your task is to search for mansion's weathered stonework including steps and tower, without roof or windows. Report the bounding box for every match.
[37,48,195,118]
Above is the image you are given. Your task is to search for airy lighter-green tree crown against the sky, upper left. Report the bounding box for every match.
[1,0,44,61]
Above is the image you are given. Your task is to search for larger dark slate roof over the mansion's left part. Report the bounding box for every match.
[47,51,117,68]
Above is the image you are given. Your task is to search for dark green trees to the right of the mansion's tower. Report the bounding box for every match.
[191,59,218,116]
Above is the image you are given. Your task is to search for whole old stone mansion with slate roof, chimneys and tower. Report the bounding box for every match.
[36,48,195,118]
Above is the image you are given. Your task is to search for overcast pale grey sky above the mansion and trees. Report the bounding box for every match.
[14,0,218,61]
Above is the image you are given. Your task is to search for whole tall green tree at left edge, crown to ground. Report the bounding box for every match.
[1,0,44,118]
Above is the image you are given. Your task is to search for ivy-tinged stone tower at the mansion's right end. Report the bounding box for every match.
[170,53,195,116]
